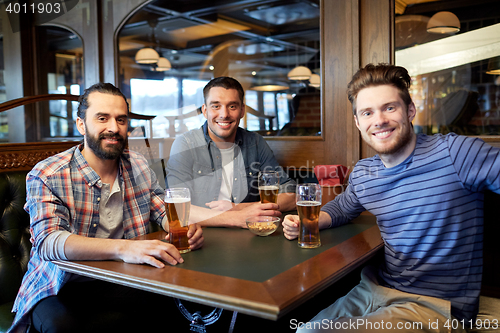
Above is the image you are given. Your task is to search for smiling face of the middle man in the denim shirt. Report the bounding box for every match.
[202,87,245,144]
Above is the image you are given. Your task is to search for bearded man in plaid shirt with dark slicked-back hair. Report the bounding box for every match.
[10,83,203,332]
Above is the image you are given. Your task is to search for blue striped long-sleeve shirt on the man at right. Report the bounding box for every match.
[323,134,500,320]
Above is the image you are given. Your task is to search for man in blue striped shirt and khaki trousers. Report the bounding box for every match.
[283,64,500,332]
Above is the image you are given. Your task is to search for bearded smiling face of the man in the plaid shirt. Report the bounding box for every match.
[77,92,128,160]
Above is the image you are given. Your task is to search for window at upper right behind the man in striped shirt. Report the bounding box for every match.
[395,1,500,135]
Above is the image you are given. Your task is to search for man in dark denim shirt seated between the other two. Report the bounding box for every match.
[166,77,295,228]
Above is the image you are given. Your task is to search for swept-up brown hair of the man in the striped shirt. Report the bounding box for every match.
[347,64,412,115]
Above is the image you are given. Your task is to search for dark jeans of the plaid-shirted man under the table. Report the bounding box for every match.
[32,281,232,333]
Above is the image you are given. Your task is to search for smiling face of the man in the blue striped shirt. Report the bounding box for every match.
[354,85,416,167]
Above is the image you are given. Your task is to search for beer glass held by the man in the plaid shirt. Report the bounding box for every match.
[165,187,191,253]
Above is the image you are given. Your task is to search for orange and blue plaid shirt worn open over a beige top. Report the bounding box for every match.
[10,146,165,332]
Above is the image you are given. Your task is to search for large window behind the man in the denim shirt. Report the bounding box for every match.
[118,0,321,138]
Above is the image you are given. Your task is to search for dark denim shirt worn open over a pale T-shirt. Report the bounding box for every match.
[165,122,295,207]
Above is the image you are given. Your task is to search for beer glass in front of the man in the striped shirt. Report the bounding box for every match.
[296,183,321,249]
